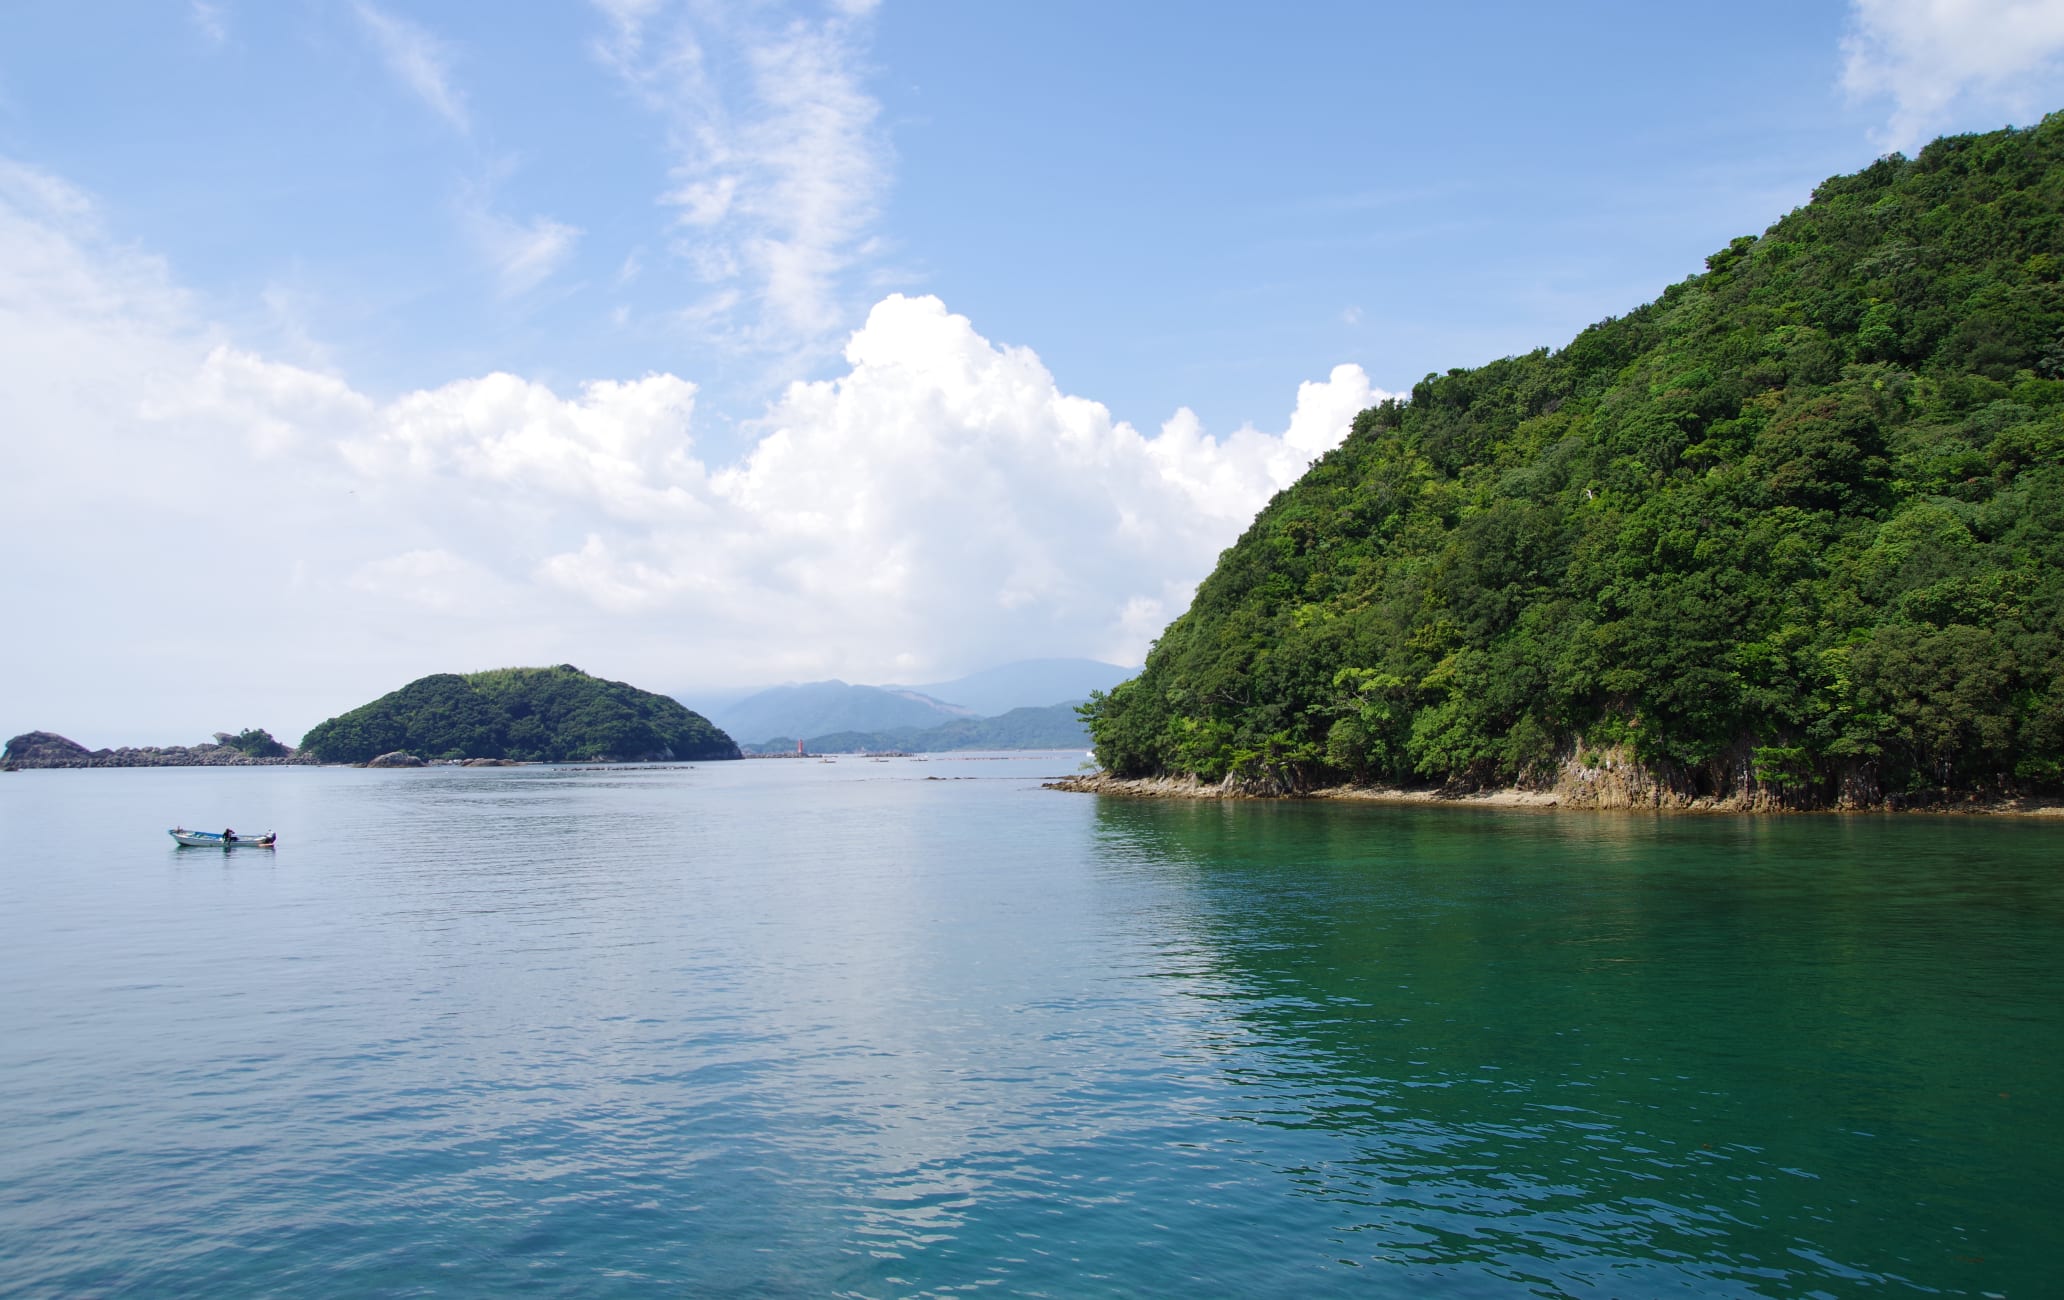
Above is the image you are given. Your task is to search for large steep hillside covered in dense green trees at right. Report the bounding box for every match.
[1086,113,2064,805]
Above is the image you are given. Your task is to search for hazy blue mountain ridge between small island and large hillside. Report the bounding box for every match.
[702,658,1131,749]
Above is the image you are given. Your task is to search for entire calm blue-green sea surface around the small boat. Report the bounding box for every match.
[0,755,2064,1298]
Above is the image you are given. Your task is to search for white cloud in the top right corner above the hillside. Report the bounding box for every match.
[1841,0,2064,149]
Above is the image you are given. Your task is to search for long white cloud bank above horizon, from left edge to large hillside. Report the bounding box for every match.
[0,165,1387,739]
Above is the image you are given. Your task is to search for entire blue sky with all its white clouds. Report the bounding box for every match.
[0,0,2064,743]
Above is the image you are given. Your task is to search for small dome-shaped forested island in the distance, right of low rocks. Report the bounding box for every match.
[301,664,739,763]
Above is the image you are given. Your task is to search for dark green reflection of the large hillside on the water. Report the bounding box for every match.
[1098,803,2064,1294]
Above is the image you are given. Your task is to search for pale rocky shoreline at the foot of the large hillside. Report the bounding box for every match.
[1044,772,2064,817]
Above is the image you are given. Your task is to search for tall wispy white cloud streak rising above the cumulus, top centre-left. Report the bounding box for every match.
[596,0,890,353]
